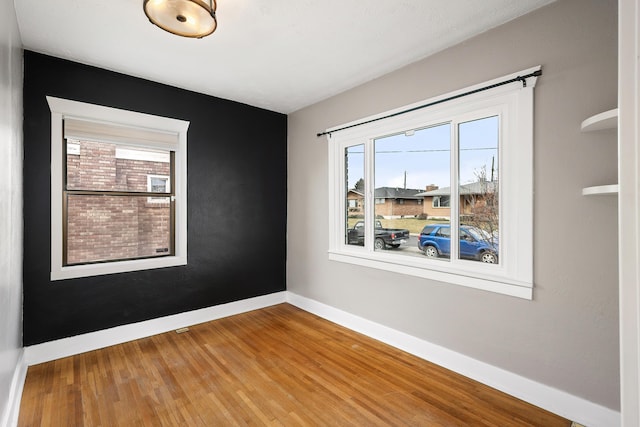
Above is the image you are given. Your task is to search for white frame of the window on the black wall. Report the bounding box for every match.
[47,96,189,281]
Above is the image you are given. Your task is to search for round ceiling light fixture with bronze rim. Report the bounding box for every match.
[143,0,218,39]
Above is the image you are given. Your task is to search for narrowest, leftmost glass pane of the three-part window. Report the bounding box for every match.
[344,144,364,245]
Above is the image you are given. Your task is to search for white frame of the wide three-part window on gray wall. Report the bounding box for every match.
[326,66,541,299]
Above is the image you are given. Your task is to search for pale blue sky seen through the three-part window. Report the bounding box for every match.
[347,116,499,189]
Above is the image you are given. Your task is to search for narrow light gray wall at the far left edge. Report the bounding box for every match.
[0,0,22,424]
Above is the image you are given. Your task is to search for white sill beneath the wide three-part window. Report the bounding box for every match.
[329,251,533,300]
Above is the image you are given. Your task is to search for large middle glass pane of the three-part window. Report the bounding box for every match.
[374,123,451,259]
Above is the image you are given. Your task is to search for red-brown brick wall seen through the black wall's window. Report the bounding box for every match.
[66,141,171,265]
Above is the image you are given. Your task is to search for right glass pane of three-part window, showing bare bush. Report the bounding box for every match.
[458,116,500,263]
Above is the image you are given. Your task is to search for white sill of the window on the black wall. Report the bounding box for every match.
[51,256,187,281]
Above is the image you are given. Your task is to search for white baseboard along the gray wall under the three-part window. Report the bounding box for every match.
[287,292,621,427]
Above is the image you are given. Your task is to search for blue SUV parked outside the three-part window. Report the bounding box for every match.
[418,224,498,264]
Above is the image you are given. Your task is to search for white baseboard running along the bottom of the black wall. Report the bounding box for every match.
[24,291,286,366]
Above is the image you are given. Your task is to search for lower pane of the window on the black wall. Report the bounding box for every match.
[66,194,172,265]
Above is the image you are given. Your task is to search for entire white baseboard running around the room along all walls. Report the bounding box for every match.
[18,292,621,427]
